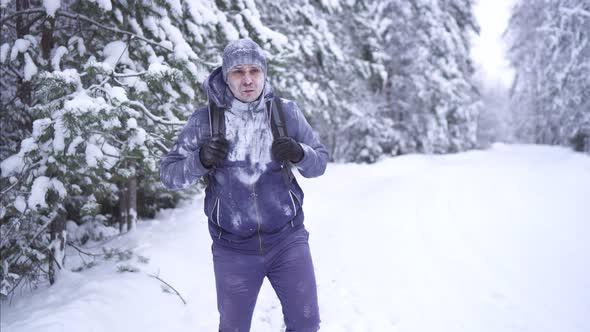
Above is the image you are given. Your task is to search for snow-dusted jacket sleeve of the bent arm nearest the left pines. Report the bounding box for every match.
[160,115,209,190]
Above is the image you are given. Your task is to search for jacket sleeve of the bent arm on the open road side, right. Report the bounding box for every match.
[293,103,328,178]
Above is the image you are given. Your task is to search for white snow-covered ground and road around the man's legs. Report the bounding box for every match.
[1,145,590,332]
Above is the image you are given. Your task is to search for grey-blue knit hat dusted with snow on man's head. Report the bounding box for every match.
[221,38,266,82]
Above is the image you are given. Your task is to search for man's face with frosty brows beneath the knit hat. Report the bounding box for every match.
[227,65,264,103]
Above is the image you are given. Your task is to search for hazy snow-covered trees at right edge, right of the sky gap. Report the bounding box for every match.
[507,0,590,152]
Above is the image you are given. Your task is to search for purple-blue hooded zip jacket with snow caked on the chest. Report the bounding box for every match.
[160,68,328,251]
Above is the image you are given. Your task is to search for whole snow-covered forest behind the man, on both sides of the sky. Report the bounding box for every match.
[0,0,590,326]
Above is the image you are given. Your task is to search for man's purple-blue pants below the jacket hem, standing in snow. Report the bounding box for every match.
[212,225,320,332]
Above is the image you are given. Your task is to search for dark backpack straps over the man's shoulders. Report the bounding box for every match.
[209,96,295,185]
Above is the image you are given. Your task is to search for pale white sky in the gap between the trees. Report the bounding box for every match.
[472,0,514,87]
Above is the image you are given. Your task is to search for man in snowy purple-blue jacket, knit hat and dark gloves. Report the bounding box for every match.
[160,39,328,332]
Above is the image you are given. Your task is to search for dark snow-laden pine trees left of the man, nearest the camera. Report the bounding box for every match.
[0,0,294,295]
